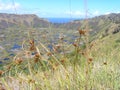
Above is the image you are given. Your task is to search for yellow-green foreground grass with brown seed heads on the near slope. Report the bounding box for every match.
[0,30,120,90]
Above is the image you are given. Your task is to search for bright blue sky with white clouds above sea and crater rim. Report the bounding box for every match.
[0,0,120,18]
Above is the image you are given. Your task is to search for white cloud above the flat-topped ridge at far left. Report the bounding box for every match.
[0,2,20,10]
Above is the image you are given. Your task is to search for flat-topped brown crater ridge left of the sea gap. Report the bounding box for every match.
[0,13,49,29]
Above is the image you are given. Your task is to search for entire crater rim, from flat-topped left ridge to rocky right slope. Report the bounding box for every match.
[0,13,120,38]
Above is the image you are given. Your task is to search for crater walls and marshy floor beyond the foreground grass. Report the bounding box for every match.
[0,13,120,62]
